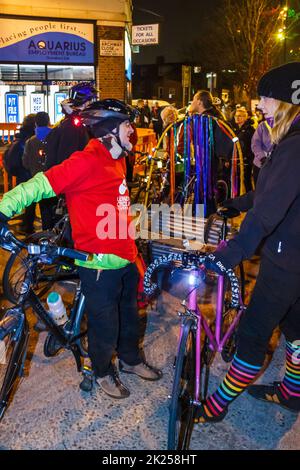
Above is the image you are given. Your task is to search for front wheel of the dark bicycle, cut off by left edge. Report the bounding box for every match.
[0,312,29,421]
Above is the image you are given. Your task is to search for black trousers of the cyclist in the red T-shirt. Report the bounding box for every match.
[79,264,142,377]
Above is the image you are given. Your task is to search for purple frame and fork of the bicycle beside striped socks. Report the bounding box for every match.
[185,269,244,403]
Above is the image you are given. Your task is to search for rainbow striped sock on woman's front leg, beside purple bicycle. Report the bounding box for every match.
[204,355,261,417]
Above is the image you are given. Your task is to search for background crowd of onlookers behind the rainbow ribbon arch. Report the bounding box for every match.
[135,90,272,201]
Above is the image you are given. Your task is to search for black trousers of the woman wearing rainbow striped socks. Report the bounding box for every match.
[237,257,300,366]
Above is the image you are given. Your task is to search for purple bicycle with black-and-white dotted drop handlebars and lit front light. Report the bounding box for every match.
[144,209,245,450]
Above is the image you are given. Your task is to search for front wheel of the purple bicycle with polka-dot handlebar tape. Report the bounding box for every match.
[168,318,196,450]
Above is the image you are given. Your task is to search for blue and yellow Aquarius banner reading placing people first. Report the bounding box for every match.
[0,18,94,64]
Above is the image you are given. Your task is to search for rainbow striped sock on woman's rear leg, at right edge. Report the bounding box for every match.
[279,341,300,400]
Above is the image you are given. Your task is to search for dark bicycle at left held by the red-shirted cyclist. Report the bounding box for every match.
[0,228,90,420]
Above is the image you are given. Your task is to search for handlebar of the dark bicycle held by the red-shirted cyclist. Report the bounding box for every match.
[0,227,93,261]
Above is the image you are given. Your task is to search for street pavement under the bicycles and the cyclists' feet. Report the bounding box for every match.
[0,232,300,450]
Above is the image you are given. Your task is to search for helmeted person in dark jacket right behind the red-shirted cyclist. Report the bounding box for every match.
[46,82,97,168]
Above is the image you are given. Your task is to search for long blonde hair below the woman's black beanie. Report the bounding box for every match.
[271,100,300,144]
